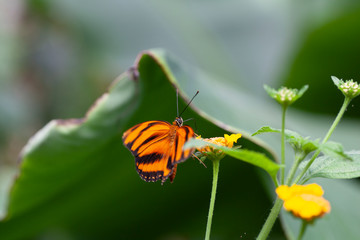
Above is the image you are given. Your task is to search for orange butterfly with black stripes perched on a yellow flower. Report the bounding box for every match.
[122,91,199,184]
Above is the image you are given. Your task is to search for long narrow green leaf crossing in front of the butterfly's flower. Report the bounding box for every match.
[184,139,281,182]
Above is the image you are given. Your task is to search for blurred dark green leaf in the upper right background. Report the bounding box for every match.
[284,9,360,118]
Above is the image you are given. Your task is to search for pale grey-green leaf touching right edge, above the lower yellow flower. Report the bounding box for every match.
[299,151,360,182]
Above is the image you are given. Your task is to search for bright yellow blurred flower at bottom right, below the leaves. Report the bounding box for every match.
[276,183,331,221]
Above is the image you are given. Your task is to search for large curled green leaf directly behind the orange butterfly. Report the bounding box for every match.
[0,50,278,239]
